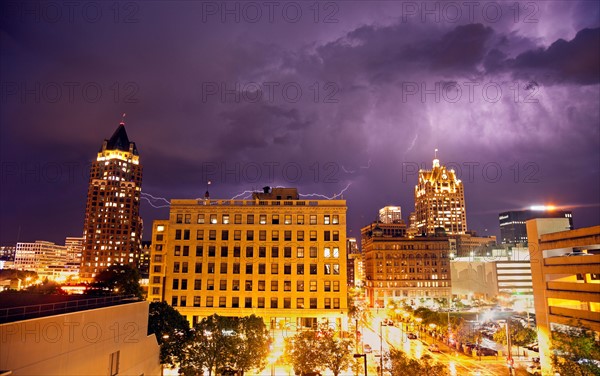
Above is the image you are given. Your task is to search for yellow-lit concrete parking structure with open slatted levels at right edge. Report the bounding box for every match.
[527,218,600,374]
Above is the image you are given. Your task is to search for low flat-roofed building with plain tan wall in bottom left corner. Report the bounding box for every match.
[0,294,161,376]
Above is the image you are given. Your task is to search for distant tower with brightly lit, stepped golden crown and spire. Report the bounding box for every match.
[415,149,467,235]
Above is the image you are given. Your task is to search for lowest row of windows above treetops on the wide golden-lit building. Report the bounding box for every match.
[164,296,340,309]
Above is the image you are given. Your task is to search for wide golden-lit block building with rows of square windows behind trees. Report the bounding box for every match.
[148,187,348,329]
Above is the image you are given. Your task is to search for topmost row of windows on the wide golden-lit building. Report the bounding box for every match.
[175,214,340,225]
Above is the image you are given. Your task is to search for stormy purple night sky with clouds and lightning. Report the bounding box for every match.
[0,1,600,245]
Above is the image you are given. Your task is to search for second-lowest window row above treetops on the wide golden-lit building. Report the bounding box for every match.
[168,277,340,292]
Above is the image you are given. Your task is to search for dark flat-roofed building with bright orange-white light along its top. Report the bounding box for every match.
[498,206,574,245]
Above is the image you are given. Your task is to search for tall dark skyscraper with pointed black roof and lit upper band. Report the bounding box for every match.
[80,121,142,280]
